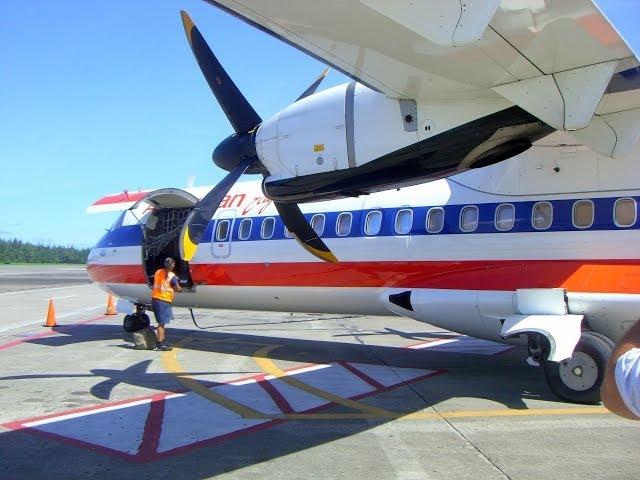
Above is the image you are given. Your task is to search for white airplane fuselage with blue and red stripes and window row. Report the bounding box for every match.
[88,136,640,340]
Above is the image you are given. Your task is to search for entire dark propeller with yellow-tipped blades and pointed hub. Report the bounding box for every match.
[180,10,338,263]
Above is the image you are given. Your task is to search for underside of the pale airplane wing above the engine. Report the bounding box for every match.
[206,0,640,157]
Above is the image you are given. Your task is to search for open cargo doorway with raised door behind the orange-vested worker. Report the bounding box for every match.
[128,188,198,291]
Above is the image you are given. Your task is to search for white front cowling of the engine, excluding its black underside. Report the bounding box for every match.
[255,82,418,199]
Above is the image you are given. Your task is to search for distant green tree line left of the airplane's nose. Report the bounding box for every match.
[0,238,89,263]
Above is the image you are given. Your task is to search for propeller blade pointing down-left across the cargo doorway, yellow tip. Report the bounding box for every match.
[180,158,255,262]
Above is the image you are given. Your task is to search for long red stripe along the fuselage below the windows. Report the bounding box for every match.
[87,260,640,293]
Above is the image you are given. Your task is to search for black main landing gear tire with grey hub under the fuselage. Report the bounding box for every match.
[542,332,614,404]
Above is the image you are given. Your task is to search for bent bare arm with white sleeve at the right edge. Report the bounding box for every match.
[600,320,640,420]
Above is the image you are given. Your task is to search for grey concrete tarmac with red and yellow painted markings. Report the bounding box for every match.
[0,266,640,480]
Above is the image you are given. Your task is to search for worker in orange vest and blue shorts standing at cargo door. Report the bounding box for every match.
[151,257,182,352]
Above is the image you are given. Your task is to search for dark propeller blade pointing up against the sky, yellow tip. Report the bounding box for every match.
[180,10,262,133]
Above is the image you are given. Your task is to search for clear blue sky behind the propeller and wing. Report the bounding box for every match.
[0,0,640,247]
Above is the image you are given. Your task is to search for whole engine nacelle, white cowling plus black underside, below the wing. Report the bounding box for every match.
[255,82,553,202]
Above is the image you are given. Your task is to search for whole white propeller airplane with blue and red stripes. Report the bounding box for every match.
[87,0,640,403]
